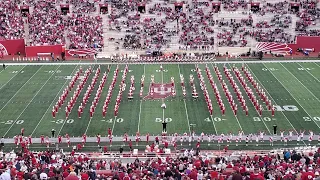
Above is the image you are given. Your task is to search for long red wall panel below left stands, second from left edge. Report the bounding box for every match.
[26,45,63,57]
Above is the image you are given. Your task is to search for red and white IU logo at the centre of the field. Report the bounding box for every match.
[144,83,174,99]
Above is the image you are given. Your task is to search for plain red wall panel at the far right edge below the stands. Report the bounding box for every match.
[288,36,320,52]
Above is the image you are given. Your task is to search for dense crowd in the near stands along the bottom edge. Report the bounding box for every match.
[0,144,320,180]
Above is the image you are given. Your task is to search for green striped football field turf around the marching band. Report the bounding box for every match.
[0,62,320,137]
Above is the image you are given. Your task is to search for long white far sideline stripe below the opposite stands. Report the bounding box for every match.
[6,59,320,66]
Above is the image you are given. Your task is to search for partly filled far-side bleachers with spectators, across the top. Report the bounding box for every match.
[0,0,320,51]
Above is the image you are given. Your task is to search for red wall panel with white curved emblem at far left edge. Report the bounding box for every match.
[0,39,26,55]
